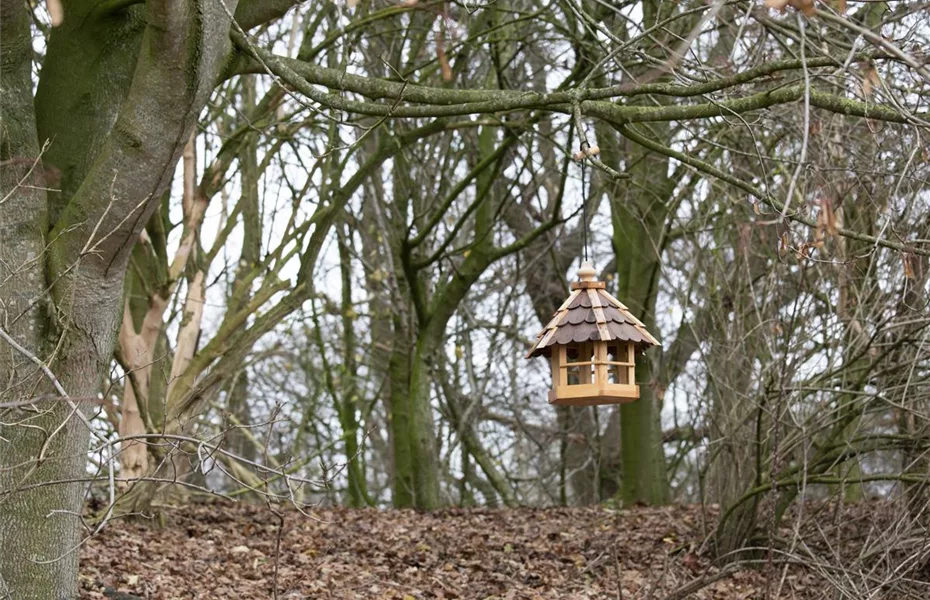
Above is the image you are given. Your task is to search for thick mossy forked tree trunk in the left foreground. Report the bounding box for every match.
[0,0,235,600]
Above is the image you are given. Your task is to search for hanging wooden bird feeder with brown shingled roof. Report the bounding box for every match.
[526,261,659,406]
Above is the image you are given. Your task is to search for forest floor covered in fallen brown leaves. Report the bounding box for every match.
[81,504,864,600]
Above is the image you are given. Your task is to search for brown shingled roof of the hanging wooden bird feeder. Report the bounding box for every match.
[526,263,659,358]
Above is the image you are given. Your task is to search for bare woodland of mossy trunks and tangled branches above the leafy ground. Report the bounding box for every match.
[0,0,930,598]
